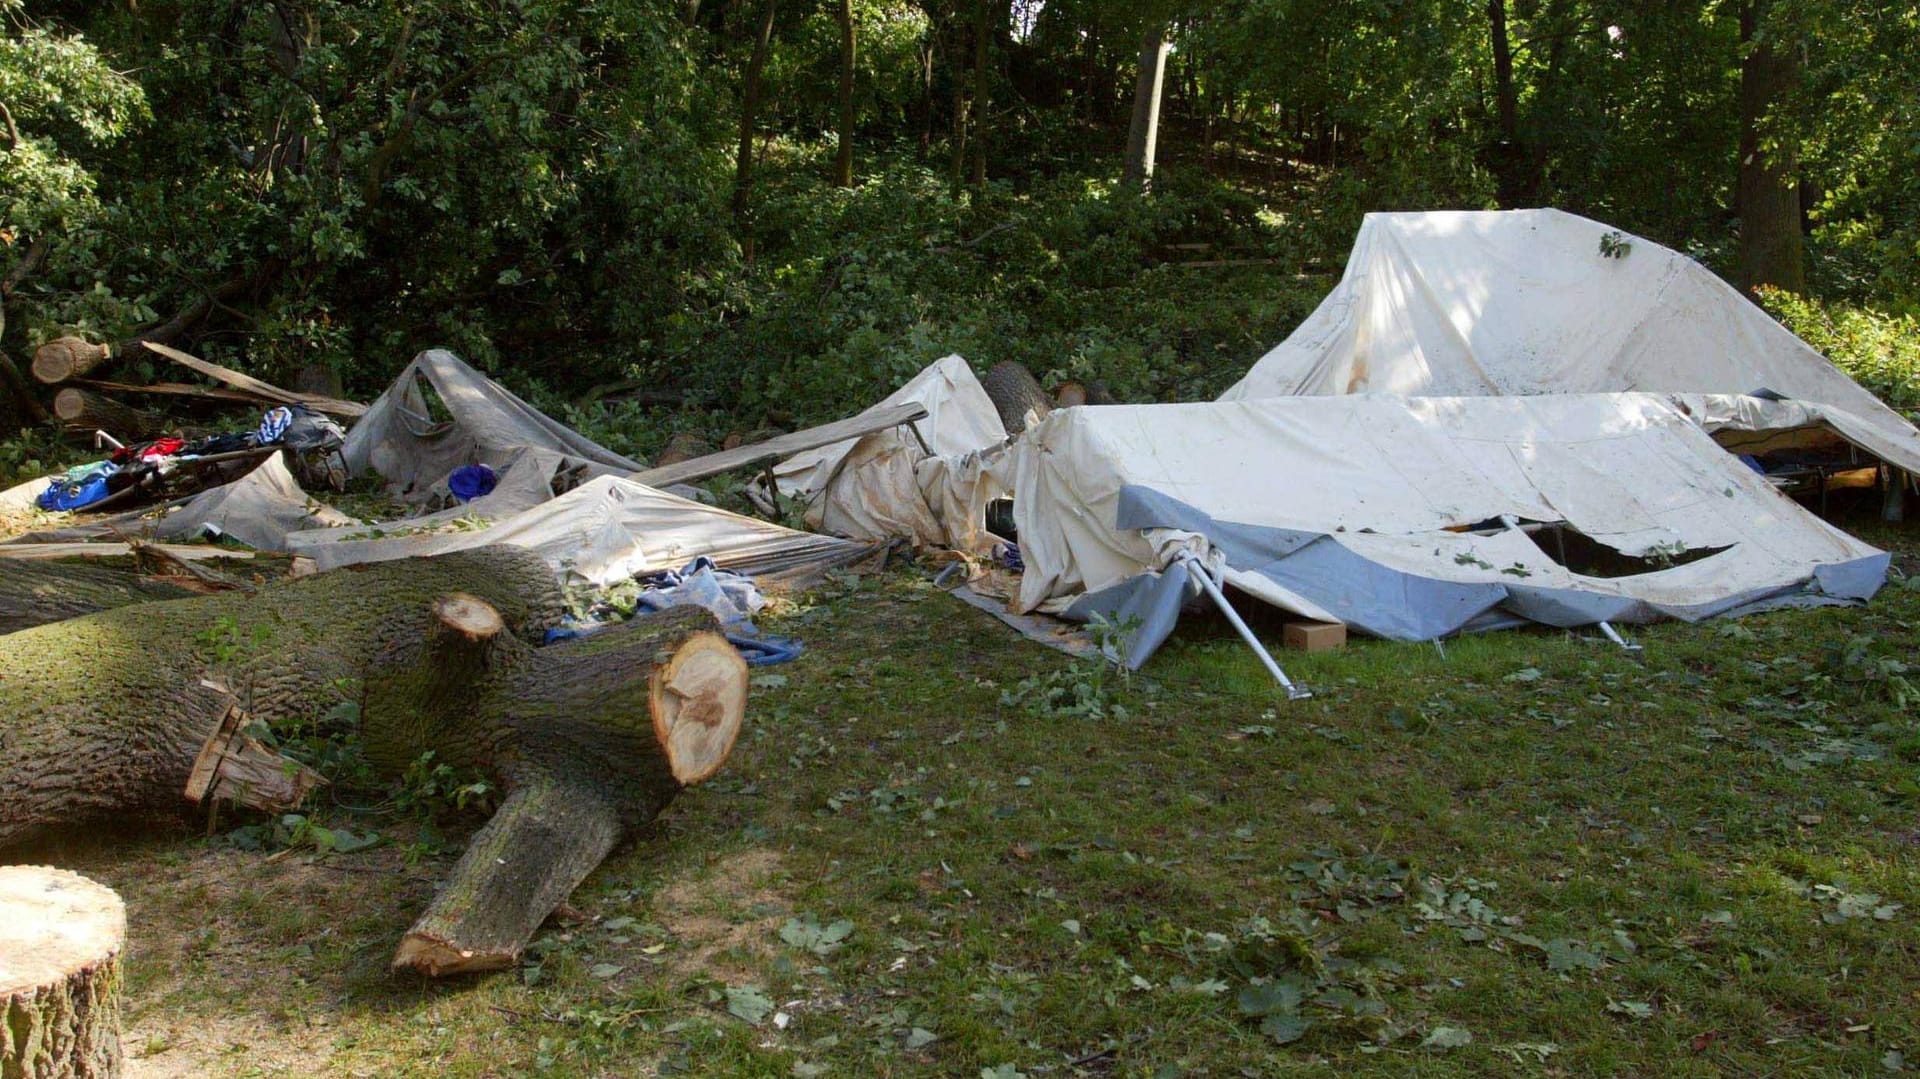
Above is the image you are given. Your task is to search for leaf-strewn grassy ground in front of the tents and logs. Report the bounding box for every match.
[46,510,1920,1079]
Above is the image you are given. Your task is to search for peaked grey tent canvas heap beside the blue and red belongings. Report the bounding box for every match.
[342,349,645,503]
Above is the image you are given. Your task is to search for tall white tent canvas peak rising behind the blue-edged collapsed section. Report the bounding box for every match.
[1221,209,1920,468]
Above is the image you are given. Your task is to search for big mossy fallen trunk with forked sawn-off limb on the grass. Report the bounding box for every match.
[0,547,747,975]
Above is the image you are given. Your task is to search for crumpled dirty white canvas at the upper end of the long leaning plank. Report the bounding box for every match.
[774,355,1006,549]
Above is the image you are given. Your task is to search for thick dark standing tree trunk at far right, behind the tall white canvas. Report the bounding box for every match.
[1736,0,1807,292]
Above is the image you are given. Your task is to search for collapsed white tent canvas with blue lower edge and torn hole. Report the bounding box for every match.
[1012,394,1887,662]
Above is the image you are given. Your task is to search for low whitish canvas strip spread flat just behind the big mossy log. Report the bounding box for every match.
[288,470,872,586]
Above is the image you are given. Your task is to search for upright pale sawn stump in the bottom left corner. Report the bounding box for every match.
[0,866,127,1079]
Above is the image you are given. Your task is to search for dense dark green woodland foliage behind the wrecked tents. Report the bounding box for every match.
[0,0,1920,437]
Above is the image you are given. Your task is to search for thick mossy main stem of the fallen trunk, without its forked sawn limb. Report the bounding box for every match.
[0,547,564,847]
